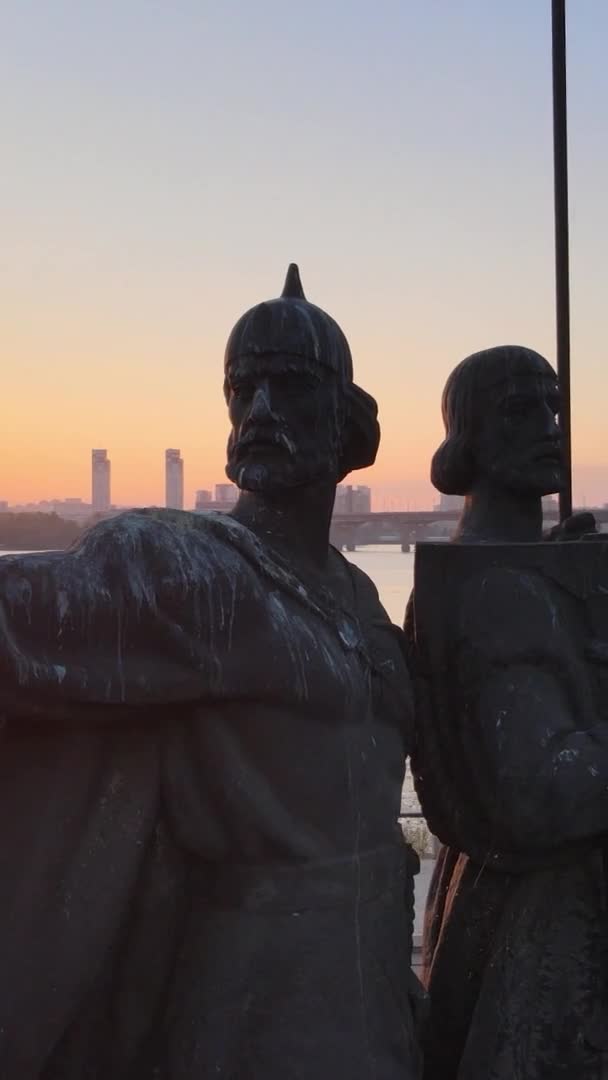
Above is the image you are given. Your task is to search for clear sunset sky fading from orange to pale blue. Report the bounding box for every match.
[0,0,608,509]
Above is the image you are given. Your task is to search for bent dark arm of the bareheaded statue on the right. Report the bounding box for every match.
[460,572,608,849]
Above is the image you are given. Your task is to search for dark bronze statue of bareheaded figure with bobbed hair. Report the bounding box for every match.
[408,347,608,1080]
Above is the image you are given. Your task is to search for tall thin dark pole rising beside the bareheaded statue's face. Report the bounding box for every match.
[552,0,572,521]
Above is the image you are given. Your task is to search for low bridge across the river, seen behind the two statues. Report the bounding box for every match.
[332,507,608,551]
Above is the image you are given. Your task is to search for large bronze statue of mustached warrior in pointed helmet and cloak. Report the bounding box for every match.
[0,266,419,1080]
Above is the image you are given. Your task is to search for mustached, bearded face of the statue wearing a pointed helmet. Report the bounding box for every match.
[226,353,339,494]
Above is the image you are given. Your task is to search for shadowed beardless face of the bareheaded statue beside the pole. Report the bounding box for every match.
[475,357,564,496]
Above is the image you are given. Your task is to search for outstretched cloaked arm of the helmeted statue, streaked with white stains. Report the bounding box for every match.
[0,513,220,715]
